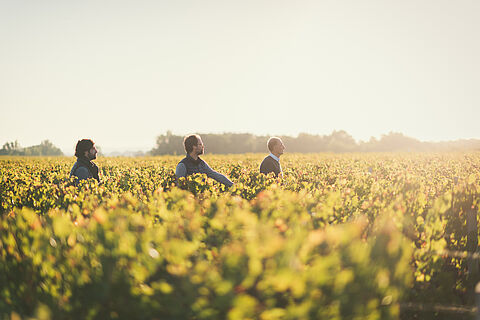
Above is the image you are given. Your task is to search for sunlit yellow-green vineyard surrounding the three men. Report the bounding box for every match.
[0,153,480,320]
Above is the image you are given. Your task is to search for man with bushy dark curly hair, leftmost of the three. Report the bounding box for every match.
[70,139,100,182]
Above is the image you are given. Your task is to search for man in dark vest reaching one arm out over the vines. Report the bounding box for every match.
[175,134,233,187]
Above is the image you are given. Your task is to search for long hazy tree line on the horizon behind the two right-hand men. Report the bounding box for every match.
[150,130,480,155]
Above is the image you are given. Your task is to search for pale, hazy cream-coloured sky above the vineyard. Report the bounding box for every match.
[0,0,480,154]
